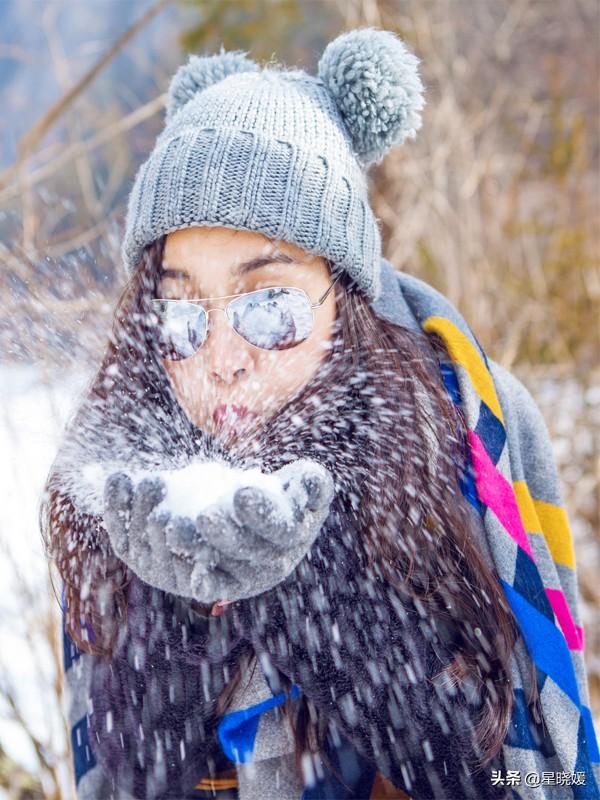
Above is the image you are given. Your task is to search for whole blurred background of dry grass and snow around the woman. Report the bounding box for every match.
[0,0,600,800]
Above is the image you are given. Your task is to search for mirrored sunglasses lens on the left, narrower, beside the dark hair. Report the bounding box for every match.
[152,300,208,361]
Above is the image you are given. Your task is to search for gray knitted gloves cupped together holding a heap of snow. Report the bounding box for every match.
[104,459,334,603]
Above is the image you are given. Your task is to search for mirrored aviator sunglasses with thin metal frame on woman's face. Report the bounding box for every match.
[152,274,340,361]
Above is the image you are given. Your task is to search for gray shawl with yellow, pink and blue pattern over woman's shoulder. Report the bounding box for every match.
[64,259,600,800]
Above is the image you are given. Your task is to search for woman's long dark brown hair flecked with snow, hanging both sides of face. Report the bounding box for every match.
[40,237,537,788]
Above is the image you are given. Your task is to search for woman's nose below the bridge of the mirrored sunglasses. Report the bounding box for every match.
[203,309,253,384]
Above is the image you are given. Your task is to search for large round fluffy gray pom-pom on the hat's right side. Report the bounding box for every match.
[318,28,425,165]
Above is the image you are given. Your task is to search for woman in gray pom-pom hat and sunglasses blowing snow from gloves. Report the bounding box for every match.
[39,29,595,799]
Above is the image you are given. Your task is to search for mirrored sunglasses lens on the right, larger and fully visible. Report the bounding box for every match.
[227,287,313,350]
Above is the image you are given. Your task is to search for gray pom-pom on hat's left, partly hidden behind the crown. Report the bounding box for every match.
[166,45,260,122]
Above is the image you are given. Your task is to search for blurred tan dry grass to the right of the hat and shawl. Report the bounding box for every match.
[373,0,600,369]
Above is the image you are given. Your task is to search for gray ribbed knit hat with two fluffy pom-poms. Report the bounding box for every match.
[122,28,425,300]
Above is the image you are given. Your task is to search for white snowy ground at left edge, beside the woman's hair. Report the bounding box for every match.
[0,365,92,796]
